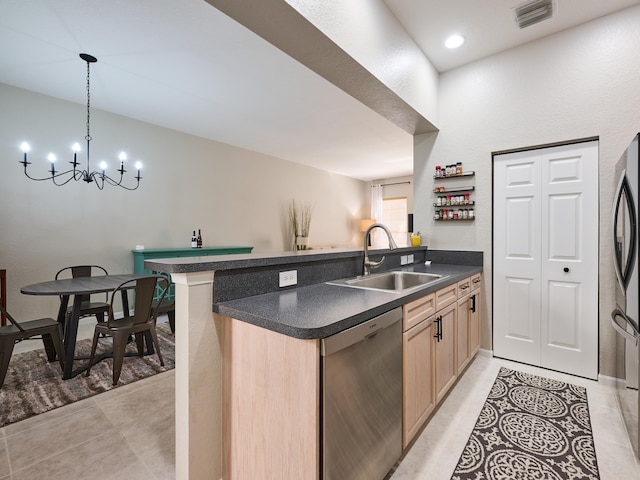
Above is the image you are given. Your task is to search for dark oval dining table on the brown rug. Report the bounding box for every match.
[20,274,153,380]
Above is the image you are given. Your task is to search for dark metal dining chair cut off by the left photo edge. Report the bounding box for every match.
[0,305,64,388]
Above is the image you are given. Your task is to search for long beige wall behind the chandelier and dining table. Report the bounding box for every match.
[0,84,369,317]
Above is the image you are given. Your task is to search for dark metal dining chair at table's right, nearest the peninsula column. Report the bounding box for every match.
[86,275,170,385]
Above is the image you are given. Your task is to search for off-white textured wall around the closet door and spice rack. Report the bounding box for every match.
[414,6,640,375]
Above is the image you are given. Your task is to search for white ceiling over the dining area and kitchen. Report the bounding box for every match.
[0,0,640,180]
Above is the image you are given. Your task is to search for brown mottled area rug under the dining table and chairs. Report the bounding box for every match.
[0,323,175,427]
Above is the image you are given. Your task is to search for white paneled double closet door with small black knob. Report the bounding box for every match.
[493,141,598,379]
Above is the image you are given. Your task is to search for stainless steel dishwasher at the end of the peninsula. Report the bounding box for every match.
[322,308,402,480]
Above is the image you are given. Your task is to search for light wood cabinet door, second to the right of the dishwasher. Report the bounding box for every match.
[432,303,458,403]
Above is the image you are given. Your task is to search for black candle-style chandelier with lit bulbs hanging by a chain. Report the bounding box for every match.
[19,53,142,190]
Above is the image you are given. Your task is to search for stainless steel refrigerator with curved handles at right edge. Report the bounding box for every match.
[611,134,640,458]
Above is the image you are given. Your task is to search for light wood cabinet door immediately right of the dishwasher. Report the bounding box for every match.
[402,318,435,448]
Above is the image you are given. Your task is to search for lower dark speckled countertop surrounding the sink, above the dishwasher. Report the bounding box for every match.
[213,263,482,339]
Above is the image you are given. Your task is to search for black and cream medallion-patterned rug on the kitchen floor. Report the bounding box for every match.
[451,368,599,480]
